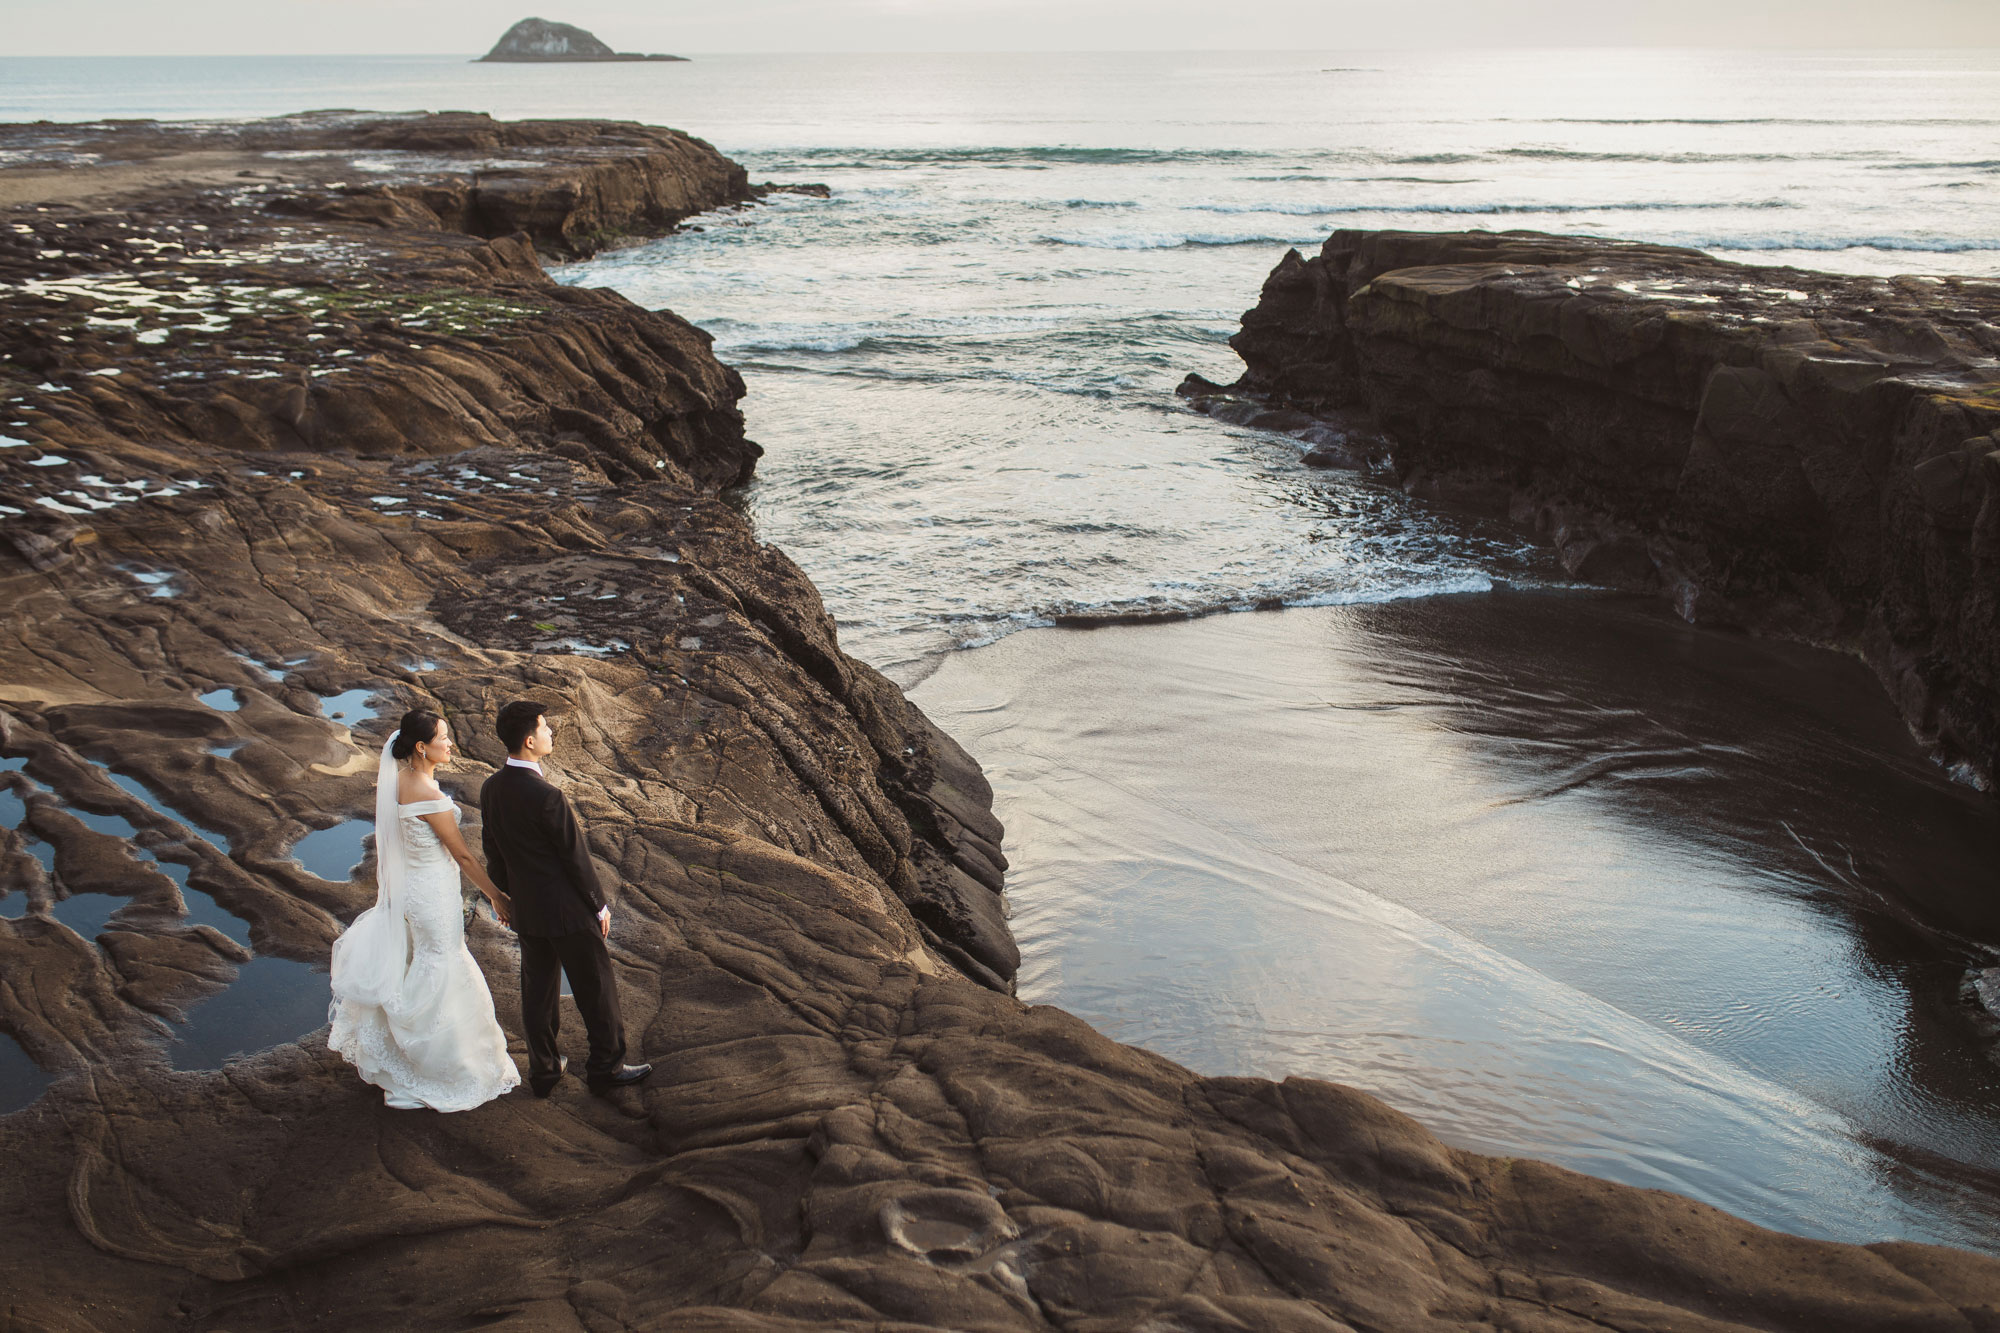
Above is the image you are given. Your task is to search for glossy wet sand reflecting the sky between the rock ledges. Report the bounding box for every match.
[912,592,2000,1251]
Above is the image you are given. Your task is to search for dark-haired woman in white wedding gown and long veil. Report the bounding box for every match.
[326,709,520,1111]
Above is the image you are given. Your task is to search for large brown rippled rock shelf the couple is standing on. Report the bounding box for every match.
[0,116,2000,1333]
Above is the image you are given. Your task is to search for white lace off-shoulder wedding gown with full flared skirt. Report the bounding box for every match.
[326,799,520,1111]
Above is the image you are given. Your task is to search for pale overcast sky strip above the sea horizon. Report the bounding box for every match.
[0,0,2000,56]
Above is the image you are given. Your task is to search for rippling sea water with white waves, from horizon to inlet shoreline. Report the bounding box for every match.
[0,50,2000,668]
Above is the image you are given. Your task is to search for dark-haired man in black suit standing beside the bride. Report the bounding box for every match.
[480,699,652,1097]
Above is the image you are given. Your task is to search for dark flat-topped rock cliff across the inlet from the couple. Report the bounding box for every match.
[1194,232,2000,783]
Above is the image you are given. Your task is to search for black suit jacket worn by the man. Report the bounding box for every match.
[480,765,608,937]
